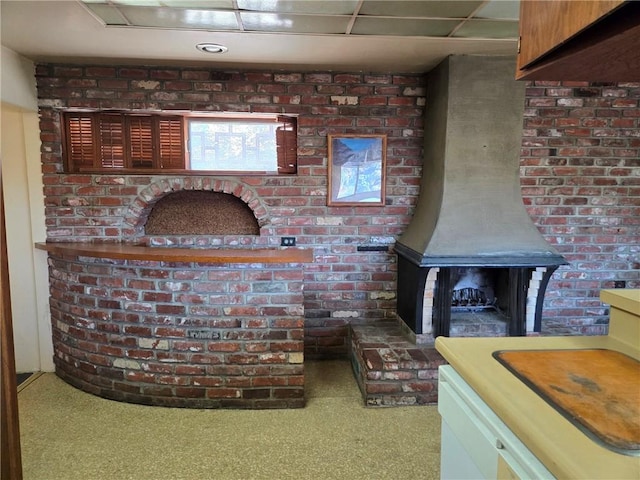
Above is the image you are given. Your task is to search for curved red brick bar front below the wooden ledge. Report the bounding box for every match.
[49,256,305,408]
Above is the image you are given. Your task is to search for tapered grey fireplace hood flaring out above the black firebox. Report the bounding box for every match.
[395,56,567,267]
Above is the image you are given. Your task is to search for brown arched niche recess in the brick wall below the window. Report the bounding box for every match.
[144,190,260,235]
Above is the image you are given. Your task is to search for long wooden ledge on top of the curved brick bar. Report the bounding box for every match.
[35,243,313,263]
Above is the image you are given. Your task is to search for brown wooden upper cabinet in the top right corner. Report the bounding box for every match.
[516,0,640,82]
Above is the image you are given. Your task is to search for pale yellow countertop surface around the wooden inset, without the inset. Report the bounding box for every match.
[436,336,640,480]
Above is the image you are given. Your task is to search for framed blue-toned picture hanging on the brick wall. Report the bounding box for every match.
[327,135,387,206]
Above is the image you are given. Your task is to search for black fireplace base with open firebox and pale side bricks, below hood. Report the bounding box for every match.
[397,254,558,343]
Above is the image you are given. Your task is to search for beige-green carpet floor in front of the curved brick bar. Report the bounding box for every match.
[18,361,440,480]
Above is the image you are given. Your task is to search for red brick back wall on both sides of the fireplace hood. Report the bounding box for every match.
[36,65,640,357]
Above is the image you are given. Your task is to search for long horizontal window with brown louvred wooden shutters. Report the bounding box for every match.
[63,112,297,174]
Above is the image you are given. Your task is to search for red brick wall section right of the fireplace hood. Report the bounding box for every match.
[521,81,640,334]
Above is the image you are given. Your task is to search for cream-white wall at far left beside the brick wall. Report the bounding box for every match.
[0,47,53,372]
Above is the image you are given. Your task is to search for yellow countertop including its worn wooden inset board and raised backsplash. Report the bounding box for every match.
[436,289,640,480]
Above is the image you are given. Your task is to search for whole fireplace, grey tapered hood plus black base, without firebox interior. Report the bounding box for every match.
[394,56,567,343]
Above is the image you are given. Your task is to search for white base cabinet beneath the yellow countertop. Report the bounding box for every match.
[438,365,554,480]
